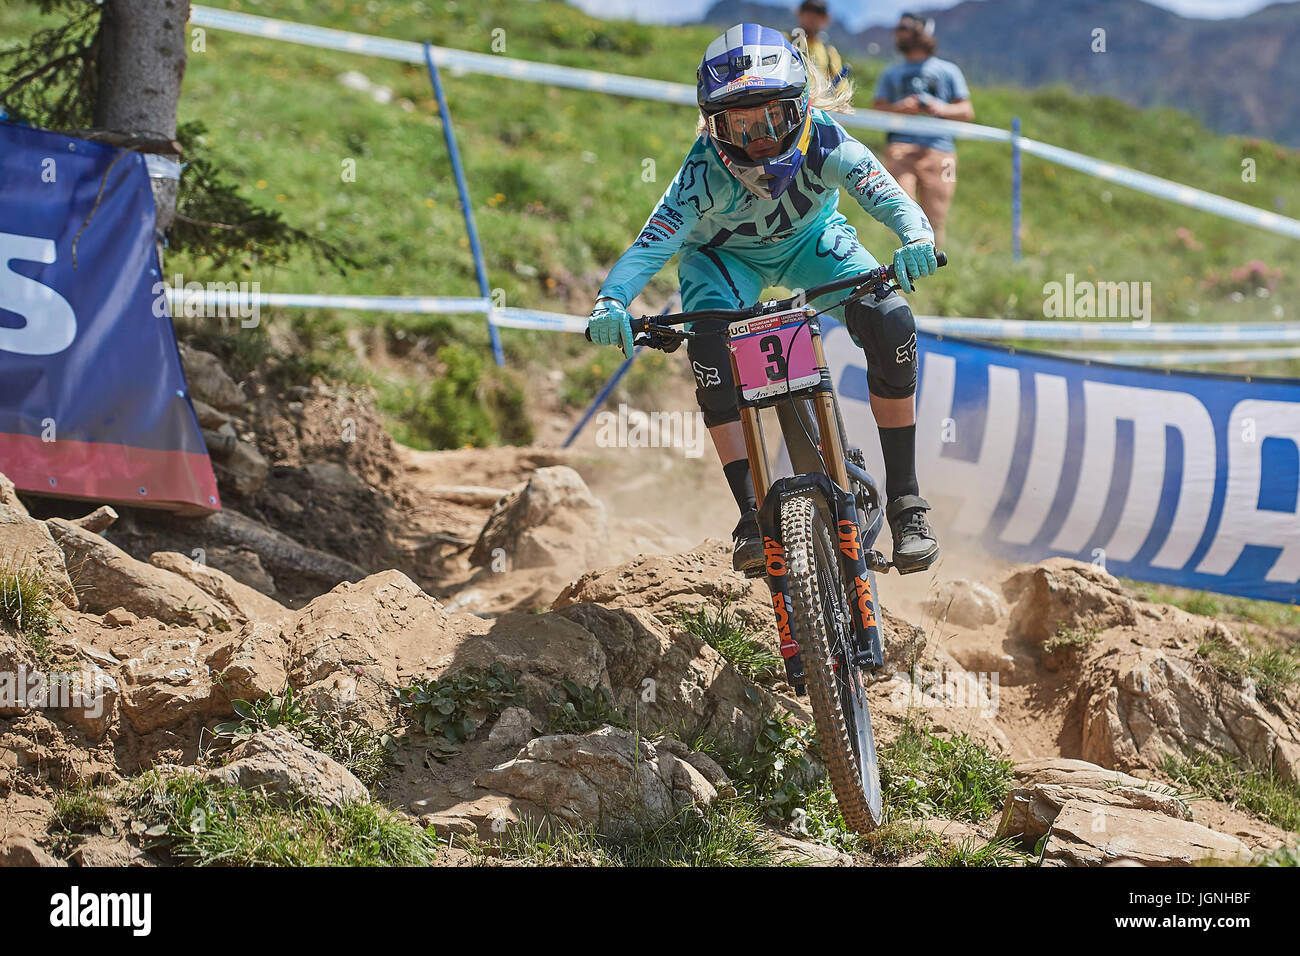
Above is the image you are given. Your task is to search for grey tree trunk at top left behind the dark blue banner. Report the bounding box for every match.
[95,0,190,261]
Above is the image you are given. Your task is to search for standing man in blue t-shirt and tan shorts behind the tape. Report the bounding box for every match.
[874,13,975,248]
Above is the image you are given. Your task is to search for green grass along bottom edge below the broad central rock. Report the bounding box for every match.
[501,800,781,866]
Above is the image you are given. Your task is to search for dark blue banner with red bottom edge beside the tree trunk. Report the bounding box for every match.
[0,122,220,510]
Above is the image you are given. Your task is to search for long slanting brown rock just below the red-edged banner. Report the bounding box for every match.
[46,518,234,627]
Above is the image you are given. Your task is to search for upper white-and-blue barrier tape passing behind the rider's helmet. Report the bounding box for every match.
[190,5,1300,238]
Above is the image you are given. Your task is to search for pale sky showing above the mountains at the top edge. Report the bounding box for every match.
[569,0,1289,30]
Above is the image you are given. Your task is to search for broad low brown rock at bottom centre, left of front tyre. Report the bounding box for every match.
[475,727,718,838]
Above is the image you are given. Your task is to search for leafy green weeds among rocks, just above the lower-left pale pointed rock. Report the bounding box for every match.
[213,685,394,787]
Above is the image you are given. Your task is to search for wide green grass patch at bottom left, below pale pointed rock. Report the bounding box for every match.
[124,773,437,866]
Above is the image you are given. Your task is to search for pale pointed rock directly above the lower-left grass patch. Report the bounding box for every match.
[207,728,371,809]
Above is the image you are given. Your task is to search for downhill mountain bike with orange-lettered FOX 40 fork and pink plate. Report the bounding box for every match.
[590,252,948,832]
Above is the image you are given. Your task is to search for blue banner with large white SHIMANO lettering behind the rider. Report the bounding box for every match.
[823,320,1300,604]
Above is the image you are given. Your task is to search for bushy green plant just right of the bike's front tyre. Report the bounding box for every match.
[880,722,1011,822]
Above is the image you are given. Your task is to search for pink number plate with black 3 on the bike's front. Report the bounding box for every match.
[728,308,822,402]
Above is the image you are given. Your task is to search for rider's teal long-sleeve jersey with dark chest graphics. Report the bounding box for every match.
[601,109,935,304]
